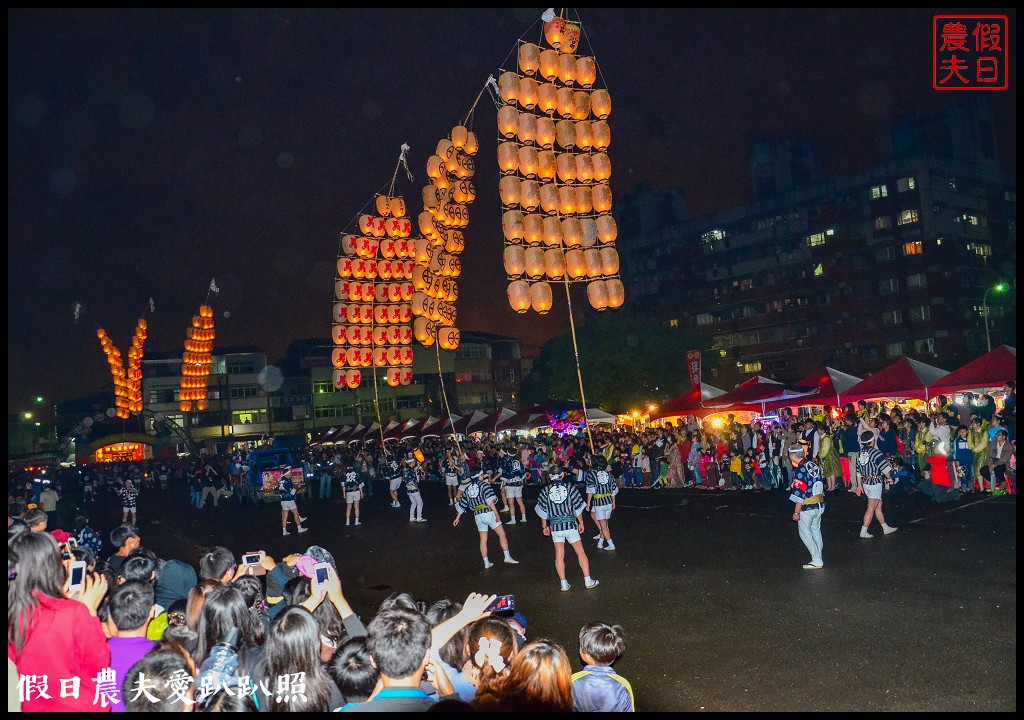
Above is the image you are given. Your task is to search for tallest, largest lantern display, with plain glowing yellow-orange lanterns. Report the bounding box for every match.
[498,9,623,313]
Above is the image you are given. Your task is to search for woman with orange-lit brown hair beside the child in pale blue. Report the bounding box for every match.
[483,640,572,713]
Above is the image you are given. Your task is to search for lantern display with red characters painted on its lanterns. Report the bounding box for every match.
[331,191,415,390]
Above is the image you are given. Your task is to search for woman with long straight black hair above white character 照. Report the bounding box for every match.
[259,606,334,713]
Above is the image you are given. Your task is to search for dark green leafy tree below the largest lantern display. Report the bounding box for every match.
[519,311,711,412]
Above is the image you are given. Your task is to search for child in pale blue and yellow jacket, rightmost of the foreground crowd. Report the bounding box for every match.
[571,622,636,713]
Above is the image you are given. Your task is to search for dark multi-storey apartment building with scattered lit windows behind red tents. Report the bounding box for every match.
[616,96,1017,387]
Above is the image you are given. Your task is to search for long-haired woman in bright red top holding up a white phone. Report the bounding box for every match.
[7,533,111,712]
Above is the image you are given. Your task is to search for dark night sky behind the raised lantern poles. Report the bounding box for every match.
[7,8,1016,412]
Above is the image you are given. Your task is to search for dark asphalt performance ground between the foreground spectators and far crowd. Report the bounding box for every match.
[94,483,1017,712]
